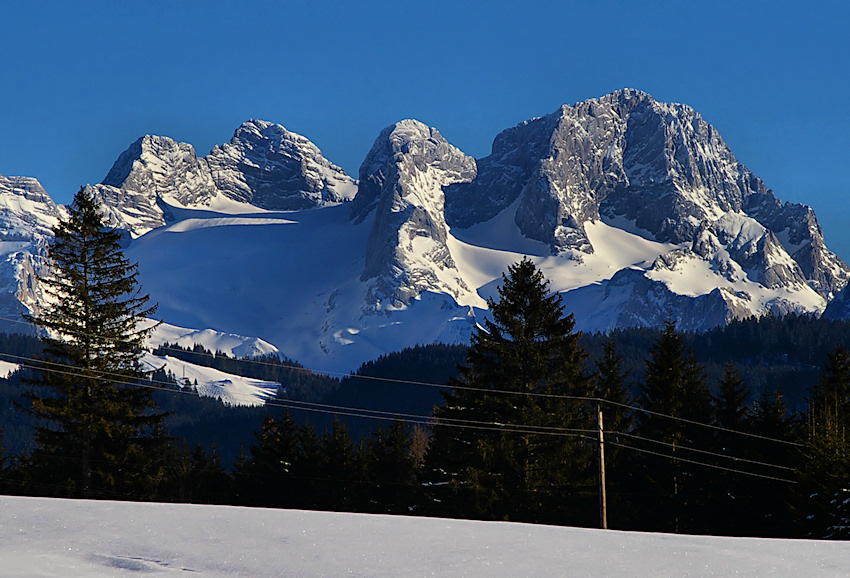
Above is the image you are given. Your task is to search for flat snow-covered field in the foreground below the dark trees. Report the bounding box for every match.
[0,497,850,578]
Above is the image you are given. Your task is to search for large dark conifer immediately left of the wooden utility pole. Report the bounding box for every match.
[426,259,596,525]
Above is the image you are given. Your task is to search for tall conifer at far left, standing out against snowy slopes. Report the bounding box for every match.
[23,189,167,497]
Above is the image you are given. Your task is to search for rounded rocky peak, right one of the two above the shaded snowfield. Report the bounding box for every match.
[206,120,357,211]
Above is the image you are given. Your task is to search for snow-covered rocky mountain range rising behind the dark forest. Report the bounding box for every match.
[3,90,850,371]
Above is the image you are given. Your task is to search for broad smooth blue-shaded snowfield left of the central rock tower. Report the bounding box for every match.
[127,205,480,372]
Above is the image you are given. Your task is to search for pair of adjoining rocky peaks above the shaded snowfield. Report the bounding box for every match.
[92,120,357,237]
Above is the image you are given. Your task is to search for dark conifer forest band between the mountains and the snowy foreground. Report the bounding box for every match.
[0,191,850,539]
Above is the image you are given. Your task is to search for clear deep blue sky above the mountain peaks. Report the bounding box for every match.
[0,0,850,260]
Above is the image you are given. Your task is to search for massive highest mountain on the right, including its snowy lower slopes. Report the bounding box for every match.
[446,90,850,329]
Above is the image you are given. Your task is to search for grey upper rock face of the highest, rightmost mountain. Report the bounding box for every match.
[446,90,850,316]
